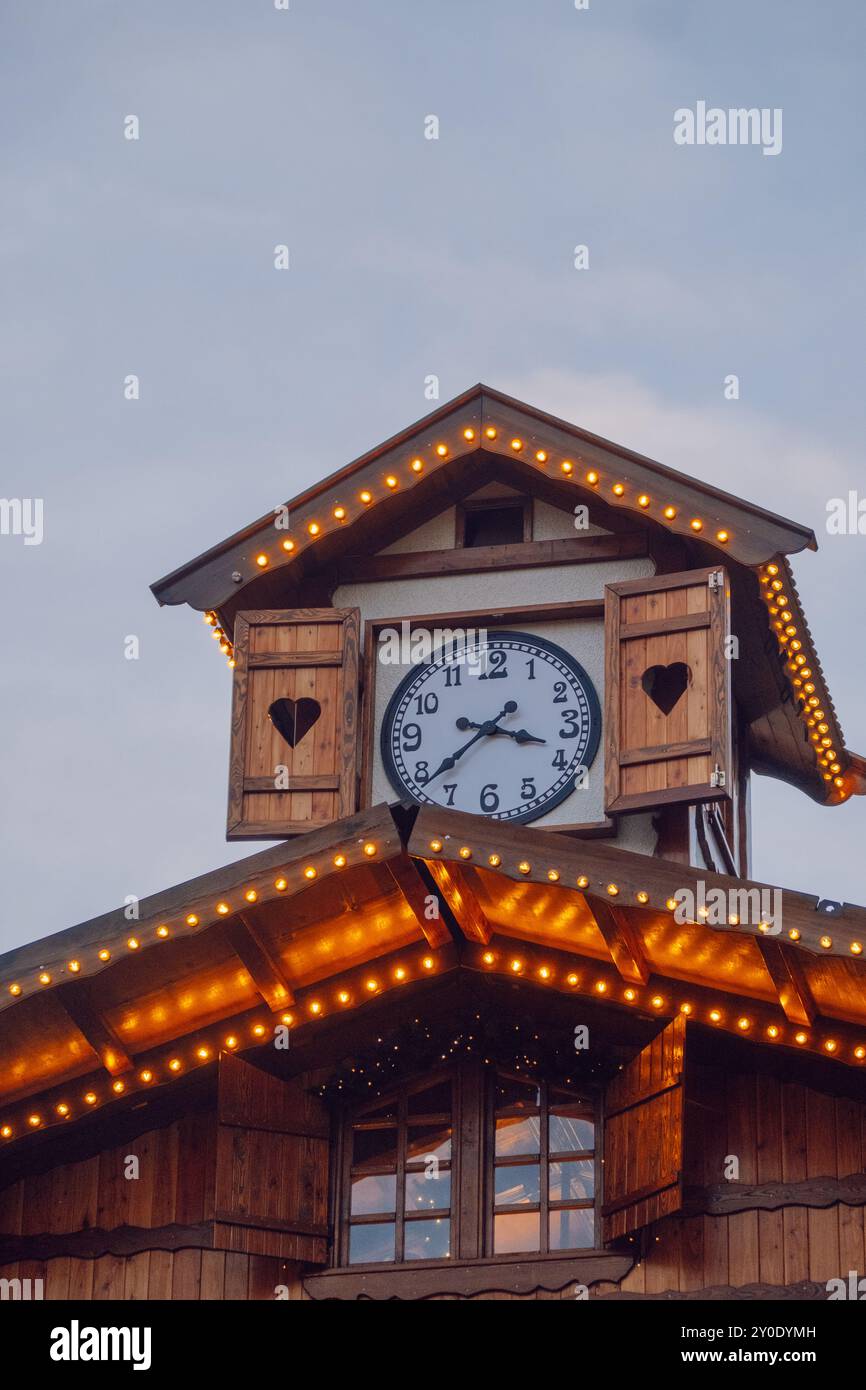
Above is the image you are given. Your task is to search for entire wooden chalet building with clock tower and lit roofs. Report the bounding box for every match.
[0,386,866,1300]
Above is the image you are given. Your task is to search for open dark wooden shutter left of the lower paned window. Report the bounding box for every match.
[214,1052,329,1265]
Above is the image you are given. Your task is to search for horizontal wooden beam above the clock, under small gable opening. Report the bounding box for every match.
[336,532,646,585]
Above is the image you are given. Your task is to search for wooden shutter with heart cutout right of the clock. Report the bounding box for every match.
[605,569,733,813]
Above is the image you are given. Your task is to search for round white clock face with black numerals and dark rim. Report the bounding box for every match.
[381,632,601,821]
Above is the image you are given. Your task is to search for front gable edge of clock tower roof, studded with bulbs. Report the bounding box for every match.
[152,384,817,612]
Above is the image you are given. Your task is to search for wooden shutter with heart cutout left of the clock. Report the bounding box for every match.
[227,609,359,840]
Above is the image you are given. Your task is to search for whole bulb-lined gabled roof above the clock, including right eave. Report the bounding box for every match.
[147,385,866,805]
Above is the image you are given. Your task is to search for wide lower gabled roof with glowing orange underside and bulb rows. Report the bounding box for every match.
[0,806,866,1161]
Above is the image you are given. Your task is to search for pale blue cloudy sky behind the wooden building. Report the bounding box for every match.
[0,0,866,949]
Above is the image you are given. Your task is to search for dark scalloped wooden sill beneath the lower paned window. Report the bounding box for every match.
[303,1250,634,1300]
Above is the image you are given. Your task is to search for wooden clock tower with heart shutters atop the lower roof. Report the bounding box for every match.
[154,386,859,874]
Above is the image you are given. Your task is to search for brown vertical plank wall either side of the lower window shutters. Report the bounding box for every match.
[0,1068,866,1300]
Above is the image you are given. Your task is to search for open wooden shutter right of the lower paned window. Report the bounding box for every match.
[602,1015,685,1241]
